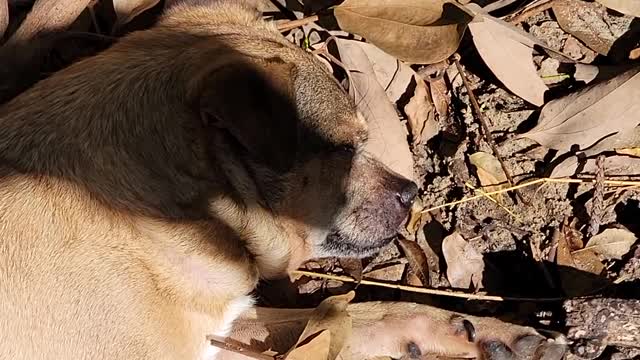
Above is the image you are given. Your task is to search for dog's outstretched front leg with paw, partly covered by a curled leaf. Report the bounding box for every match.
[220,302,565,360]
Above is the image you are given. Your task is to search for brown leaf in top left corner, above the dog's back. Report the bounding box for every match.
[8,0,91,43]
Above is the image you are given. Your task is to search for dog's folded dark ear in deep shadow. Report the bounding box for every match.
[199,59,299,172]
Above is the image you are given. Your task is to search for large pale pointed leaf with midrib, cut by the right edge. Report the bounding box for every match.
[519,68,640,151]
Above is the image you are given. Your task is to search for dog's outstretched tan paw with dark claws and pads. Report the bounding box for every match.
[344,303,566,360]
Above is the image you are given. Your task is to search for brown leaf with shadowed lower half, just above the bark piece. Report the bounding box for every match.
[554,221,604,296]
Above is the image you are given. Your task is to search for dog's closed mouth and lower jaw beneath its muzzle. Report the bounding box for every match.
[322,231,396,258]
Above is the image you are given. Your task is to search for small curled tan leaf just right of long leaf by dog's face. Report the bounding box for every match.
[404,76,440,146]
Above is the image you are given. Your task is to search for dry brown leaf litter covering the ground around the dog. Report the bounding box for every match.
[0,0,640,360]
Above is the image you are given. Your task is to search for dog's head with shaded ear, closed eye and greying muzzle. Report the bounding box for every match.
[182,7,418,272]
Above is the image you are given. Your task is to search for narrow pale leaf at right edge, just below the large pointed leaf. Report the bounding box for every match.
[551,155,640,178]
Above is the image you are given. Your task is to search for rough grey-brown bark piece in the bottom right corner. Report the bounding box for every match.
[564,298,640,348]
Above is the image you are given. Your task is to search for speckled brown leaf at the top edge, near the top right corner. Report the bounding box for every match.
[553,0,616,56]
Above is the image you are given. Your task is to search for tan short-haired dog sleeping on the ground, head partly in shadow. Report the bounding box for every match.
[0,0,564,360]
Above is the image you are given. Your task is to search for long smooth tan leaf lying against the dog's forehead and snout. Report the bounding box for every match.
[336,39,414,179]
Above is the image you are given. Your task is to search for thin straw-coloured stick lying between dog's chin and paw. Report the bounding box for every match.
[291,270,566,302]
